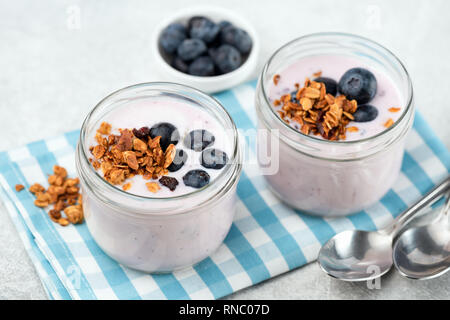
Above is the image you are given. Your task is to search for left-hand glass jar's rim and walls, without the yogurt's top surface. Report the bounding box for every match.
[76,82,242,272]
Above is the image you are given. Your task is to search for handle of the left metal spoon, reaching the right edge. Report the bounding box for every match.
[383,176,450,237]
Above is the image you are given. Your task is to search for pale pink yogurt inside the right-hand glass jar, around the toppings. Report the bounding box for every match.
[256,48,412,217]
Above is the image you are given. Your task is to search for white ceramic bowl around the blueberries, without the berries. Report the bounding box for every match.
[152,6,259,93]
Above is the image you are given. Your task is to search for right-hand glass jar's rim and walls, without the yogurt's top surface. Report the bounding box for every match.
[255,33,414,217]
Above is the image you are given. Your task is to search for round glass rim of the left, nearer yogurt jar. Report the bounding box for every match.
[78,82,242,202]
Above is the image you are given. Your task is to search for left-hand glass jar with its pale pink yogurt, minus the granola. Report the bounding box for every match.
[76,82,242,272]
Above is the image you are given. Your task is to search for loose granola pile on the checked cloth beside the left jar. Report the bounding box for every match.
[15,165,84,226]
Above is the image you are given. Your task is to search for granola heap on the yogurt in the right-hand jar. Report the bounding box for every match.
[274,77,358,140]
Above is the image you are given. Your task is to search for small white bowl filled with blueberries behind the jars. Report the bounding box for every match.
[152,6,260,93]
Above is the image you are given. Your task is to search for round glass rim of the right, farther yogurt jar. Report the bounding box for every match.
[260,32,413,146]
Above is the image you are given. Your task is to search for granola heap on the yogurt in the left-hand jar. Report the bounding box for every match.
[90,122,176,192]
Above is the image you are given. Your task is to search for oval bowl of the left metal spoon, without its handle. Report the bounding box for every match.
[318,230,392,281]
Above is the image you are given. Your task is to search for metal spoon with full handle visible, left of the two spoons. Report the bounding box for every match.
[317,177,450,281]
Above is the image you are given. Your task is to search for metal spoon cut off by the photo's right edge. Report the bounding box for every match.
[393,194,450,280]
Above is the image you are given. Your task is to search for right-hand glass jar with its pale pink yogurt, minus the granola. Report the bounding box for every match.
[255,33,414,217]
